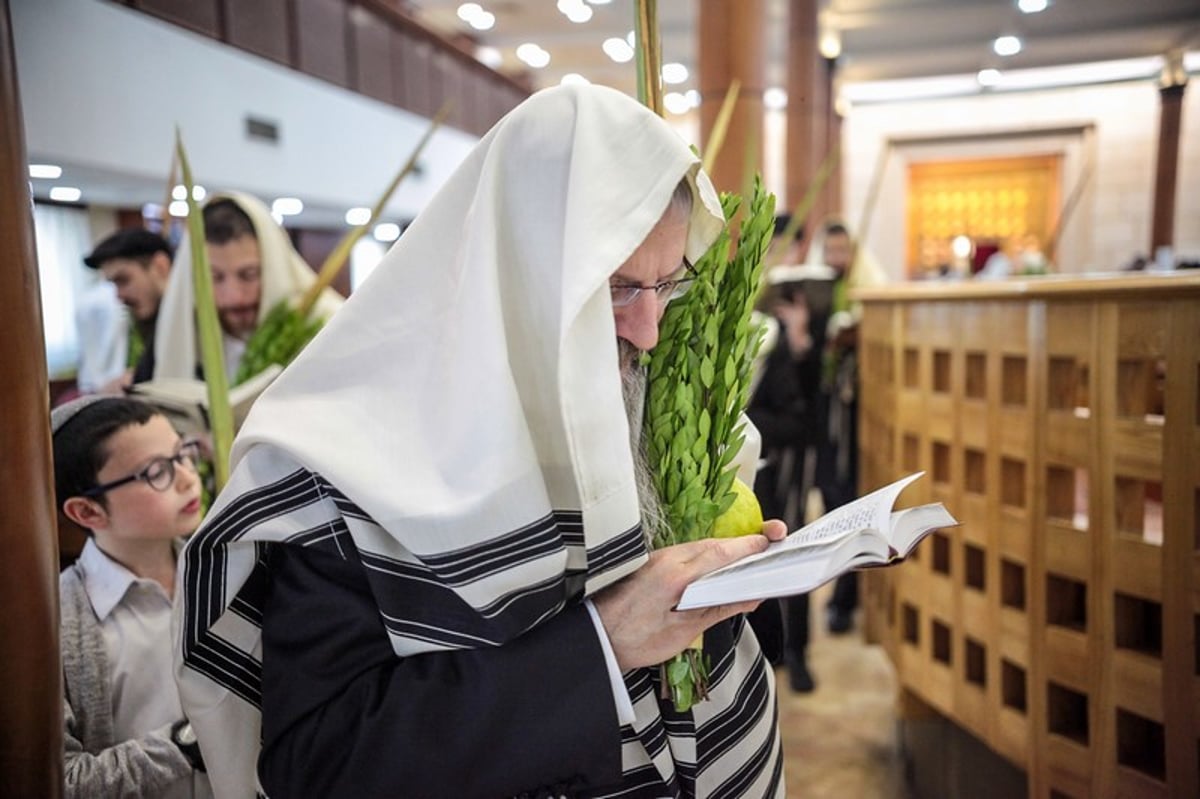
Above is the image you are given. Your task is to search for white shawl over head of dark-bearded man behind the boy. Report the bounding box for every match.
[154,192,342,380]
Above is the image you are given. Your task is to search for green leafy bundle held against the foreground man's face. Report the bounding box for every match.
[643,175,775,711]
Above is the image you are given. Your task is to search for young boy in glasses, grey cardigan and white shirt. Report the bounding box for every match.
[50,396,211,799]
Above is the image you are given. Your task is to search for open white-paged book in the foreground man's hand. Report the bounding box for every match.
[676,471,958,611]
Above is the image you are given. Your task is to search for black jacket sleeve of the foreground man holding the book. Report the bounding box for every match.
[259,537,620,799]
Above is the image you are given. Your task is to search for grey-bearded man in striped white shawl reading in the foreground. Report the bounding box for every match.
[176,85,784,798]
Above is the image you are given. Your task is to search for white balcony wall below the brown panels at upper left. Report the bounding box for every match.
[11,0,475,217]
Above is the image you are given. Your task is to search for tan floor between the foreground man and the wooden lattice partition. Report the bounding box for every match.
[775,578,911,799]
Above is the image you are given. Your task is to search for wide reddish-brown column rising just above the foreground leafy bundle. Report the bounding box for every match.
[698,0,766,192]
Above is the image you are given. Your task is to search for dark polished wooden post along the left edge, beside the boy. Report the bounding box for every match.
[0,0,62,799]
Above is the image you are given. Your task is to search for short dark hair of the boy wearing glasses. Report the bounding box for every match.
[54,397,158,510]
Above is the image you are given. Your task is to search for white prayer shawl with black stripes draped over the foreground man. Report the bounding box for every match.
[175,85,782,798]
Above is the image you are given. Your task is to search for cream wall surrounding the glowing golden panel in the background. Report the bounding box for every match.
[842,82,1200,280]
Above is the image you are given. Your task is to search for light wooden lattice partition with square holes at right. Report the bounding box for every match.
[859,274,1200,799]
